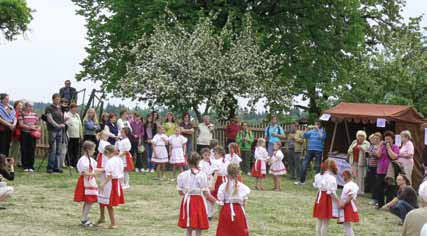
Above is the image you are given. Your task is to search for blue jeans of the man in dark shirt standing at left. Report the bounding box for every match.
[47,129,63,171]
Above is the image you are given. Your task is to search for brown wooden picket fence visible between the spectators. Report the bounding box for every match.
[36,121,303,156]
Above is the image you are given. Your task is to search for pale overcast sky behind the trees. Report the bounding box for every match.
[0,0,427,108]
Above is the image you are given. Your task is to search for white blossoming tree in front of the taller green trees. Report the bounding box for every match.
[117,15,289,120]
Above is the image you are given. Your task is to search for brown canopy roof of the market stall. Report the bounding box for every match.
[323,102,425,123]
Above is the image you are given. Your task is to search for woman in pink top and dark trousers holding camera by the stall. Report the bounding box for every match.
[375,131,399,208]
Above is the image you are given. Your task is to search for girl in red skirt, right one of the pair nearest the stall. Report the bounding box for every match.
[338,170,359,236]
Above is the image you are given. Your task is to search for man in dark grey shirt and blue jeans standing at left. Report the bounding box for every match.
[45,93,65,174]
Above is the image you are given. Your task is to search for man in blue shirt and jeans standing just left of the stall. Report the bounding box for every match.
[295,121,326,185]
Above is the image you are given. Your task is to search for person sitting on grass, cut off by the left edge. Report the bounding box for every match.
[0,154,15,209]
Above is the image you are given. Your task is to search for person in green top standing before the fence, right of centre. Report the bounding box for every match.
[236,122,254,175]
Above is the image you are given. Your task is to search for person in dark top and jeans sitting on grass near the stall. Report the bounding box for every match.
[382,174,418,223]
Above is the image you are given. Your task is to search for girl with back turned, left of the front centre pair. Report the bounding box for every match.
[177,152,216,236]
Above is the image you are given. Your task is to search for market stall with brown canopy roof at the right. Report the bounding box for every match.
[323,102,425,187]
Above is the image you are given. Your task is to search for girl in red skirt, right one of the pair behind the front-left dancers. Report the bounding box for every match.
[116,127,135,189]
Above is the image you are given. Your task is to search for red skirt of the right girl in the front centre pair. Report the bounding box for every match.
[216,204,249,236]
